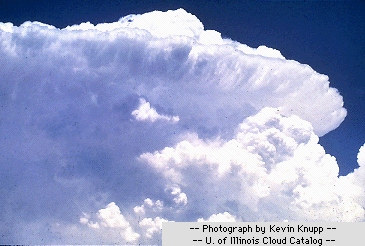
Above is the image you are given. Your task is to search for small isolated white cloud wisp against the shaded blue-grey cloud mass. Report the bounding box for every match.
[132,98,179,123]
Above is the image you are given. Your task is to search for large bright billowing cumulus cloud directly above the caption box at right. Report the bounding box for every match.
[141,108,365,221]
